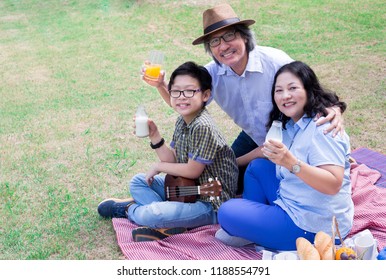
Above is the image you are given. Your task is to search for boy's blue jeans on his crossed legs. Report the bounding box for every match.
[128,173,217,228]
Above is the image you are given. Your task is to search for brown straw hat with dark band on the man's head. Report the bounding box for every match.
[193,4,255,45]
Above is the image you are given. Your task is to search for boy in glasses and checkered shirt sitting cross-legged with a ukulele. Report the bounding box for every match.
[98,62,238,241]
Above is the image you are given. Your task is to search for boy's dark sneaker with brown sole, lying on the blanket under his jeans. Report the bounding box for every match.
[132,227,187,242]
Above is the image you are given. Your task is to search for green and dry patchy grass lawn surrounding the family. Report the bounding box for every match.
[0,0,386,260]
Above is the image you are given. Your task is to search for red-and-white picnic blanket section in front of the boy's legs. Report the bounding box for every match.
[113,221,262,260]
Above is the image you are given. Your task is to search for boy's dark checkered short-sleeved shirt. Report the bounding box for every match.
[173,108,238,210]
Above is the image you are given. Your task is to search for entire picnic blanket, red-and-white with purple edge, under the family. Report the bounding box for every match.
[113,149,386,260]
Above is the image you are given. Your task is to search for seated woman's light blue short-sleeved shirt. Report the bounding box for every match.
[275,116,354,236]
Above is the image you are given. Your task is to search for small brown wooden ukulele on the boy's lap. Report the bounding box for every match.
[164,174,222,203]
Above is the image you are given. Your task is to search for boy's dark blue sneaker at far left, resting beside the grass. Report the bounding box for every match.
[98,198,135,218]
